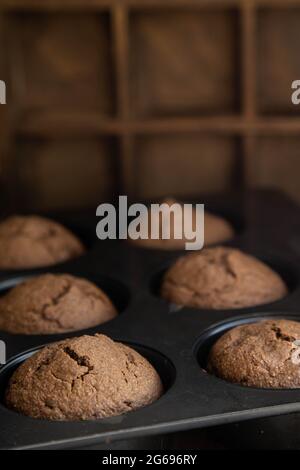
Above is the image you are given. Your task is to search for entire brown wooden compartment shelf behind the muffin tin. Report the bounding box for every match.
[0,0,300,210]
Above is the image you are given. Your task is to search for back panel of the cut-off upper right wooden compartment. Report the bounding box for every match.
[257,7,300,117]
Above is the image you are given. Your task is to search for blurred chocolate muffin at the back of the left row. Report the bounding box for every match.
[0,216,85,269]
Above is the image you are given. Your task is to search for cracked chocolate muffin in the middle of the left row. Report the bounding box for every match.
[0,274,117,334]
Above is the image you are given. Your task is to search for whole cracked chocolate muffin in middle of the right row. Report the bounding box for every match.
[161,247,288,309]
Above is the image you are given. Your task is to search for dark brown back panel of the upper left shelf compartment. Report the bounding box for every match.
[8,13,115,116]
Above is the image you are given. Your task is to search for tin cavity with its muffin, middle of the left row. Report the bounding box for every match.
[0,272,130,342]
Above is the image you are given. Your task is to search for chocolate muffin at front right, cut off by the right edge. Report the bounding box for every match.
[207,319,300,388]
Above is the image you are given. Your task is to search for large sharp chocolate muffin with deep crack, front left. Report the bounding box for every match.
[5,334,163,420]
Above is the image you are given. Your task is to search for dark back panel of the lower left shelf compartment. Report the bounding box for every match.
[16,136,116,210]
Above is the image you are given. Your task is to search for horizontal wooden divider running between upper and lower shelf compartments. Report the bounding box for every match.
[17,113,300,137]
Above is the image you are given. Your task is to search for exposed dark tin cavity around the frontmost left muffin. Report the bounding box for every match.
[0,341,176,416]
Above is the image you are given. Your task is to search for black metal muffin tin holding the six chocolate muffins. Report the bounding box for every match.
[0,191,300,449]
